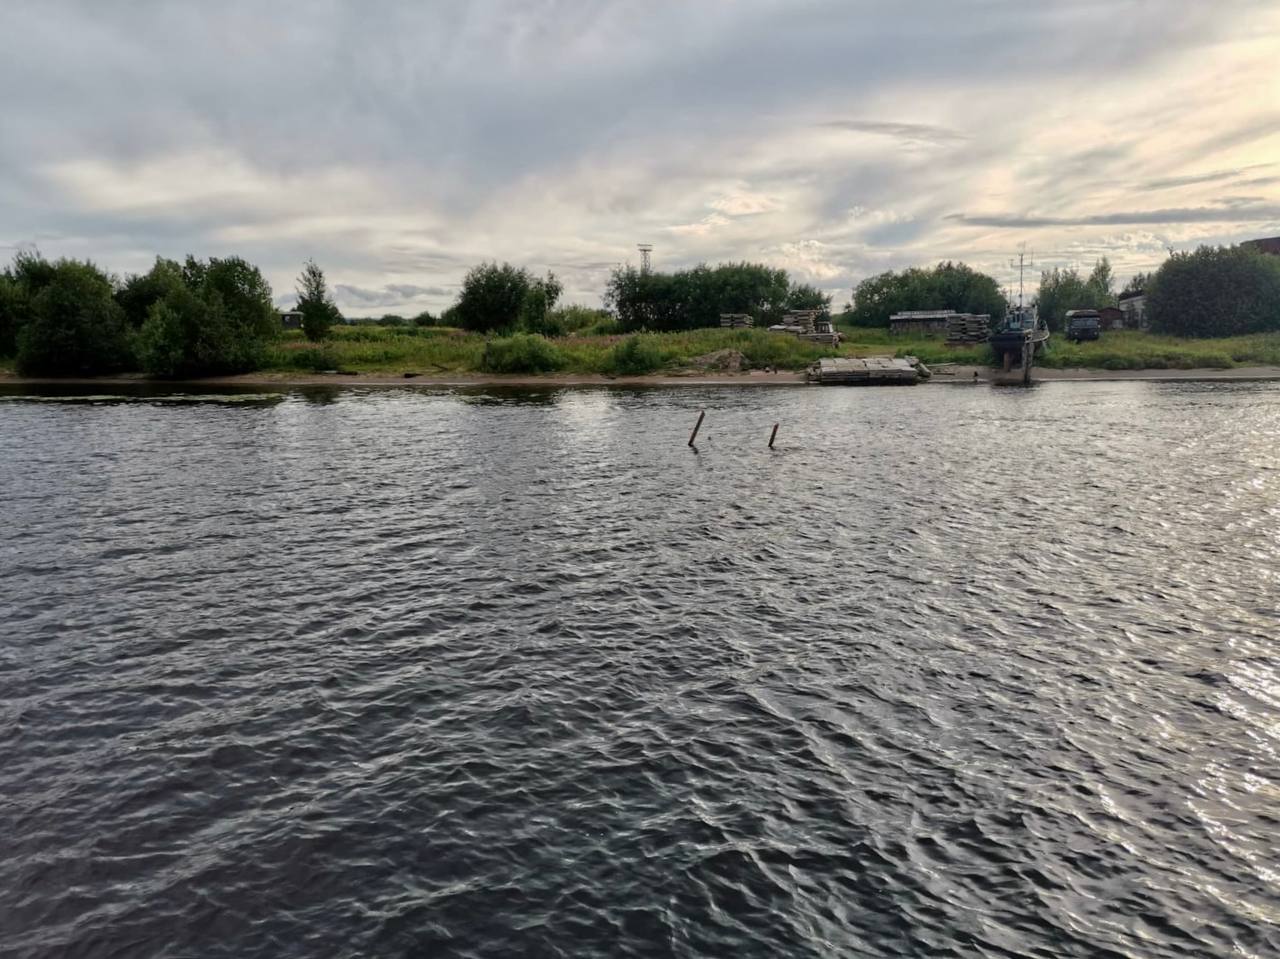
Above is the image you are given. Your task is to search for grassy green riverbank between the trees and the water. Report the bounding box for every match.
[10,326,1280,385]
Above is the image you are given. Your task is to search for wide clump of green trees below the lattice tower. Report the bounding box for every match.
[604,262,831,332]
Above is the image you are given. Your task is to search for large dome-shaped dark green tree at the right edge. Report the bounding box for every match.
[1147,246,1280,337]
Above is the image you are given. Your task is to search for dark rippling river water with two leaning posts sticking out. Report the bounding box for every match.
[0,383,1280,959]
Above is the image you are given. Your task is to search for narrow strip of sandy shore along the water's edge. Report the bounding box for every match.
[0,366,1280,389]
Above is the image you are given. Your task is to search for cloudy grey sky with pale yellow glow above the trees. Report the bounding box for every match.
[0,0,1280,315]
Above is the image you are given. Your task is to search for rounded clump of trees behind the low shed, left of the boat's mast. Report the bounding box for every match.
[841,261,1009,326]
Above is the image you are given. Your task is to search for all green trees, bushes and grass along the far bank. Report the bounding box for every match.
[0,247,1280,384]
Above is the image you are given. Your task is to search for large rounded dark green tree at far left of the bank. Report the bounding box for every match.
[15,260,131,376]
